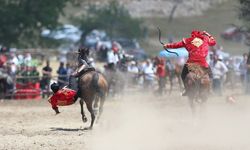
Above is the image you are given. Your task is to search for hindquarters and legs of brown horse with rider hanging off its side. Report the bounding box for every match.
[78,71,108,129]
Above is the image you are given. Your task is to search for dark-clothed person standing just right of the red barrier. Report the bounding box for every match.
[41,60,52,98]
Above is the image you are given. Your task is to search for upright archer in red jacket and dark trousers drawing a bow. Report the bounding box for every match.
[163,30,216,96]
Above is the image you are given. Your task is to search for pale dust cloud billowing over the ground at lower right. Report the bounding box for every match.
[87,93,250,150]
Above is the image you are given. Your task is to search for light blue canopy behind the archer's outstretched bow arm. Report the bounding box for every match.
[158,48,188,58]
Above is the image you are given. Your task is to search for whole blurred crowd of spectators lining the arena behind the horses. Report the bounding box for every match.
[0,41,250,98]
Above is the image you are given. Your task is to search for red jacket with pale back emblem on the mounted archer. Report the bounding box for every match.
[166,31,216,68]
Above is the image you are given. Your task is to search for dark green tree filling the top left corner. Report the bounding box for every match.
[0,0,70,47]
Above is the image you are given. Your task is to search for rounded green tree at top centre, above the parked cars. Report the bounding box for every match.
[74,0,142,41]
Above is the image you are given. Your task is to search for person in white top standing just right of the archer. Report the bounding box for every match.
[212,55,228,96]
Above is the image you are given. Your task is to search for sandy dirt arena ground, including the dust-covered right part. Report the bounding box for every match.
[0,91,250,150]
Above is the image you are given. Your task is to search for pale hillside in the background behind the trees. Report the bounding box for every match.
[61,0,248,55]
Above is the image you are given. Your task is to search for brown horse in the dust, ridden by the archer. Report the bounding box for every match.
[185,63,211,113]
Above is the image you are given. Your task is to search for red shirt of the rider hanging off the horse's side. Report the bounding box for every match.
[48,88,76,108]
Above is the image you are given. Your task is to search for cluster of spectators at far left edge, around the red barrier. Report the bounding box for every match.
[0,49,39,98]
